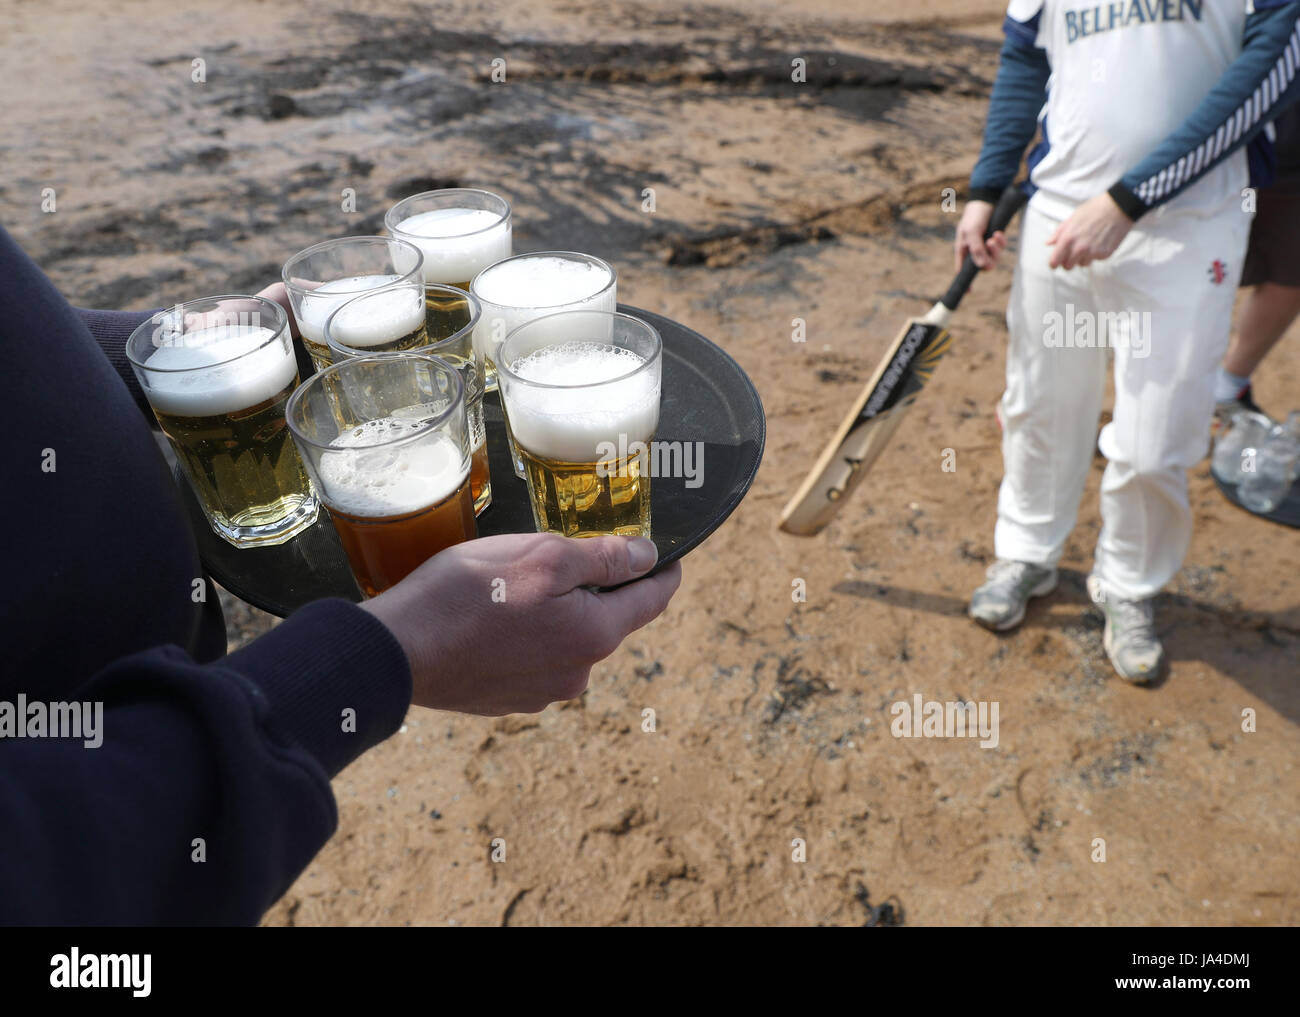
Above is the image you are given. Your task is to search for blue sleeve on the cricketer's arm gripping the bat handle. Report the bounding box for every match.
[970,16,1052,202]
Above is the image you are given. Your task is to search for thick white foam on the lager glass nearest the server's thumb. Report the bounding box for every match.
[503,342,659,463]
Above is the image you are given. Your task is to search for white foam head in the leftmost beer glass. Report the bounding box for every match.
[146,325,298,416]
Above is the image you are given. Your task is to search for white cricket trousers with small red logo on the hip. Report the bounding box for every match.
[993,200,1251,600]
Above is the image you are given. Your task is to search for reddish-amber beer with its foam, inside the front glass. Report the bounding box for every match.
[320,417,477,597]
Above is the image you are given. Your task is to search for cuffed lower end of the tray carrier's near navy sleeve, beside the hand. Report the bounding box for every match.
[217,600,411,776]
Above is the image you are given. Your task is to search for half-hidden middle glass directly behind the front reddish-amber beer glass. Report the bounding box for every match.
[325,281,491,515]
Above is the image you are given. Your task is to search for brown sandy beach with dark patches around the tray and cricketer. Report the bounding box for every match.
[0,0,1300,926]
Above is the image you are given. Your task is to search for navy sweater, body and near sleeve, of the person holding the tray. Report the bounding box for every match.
[0,229,411,925]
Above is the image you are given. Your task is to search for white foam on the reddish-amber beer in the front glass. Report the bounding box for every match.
[317,416,469,518]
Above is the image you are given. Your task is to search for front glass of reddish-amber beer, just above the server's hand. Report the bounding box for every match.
[287,352,477,597]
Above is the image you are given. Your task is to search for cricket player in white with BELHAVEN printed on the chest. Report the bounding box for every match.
[956,0,1300,683]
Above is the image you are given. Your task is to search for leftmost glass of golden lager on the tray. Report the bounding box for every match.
[126,295,317,548]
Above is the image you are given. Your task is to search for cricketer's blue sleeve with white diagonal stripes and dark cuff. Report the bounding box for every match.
[1109,0,1300,220]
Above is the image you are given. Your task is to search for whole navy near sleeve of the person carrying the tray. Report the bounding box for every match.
[0,601,411,925]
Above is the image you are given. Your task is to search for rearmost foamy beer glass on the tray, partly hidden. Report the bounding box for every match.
[384,187,512,391]
